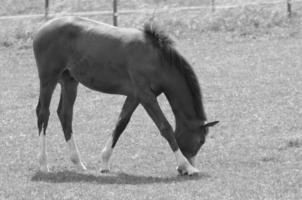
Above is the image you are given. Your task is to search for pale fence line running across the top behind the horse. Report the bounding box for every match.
[0,0,302,20]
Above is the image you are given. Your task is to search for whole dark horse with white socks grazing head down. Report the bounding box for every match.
[33,17,218,175]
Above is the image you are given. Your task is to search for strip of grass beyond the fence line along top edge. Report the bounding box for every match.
[0,0,296,16]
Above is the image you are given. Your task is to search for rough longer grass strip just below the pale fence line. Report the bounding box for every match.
[0,2,302,48]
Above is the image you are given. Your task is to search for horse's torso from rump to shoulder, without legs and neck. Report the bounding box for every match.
[34,17,163,95]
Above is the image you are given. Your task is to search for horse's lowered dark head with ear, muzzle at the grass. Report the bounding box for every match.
[176,121,219,165]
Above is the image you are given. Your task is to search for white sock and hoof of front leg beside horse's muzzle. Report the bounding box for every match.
[174,149,199,175]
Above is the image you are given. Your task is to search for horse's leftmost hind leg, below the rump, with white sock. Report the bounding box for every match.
[36,80,57,171]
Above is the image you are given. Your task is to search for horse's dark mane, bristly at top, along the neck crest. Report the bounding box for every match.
[144,23,206,120]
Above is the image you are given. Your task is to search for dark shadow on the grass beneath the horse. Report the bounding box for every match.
[31,170,210,185]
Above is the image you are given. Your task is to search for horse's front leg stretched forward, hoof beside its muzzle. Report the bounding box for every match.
[140,90,199,175]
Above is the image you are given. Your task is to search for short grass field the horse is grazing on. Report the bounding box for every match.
[0,1,302,200]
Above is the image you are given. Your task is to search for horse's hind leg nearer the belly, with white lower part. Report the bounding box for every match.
[57,71,86,170]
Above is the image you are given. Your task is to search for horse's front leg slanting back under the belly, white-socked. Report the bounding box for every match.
[101,97,138,173]
